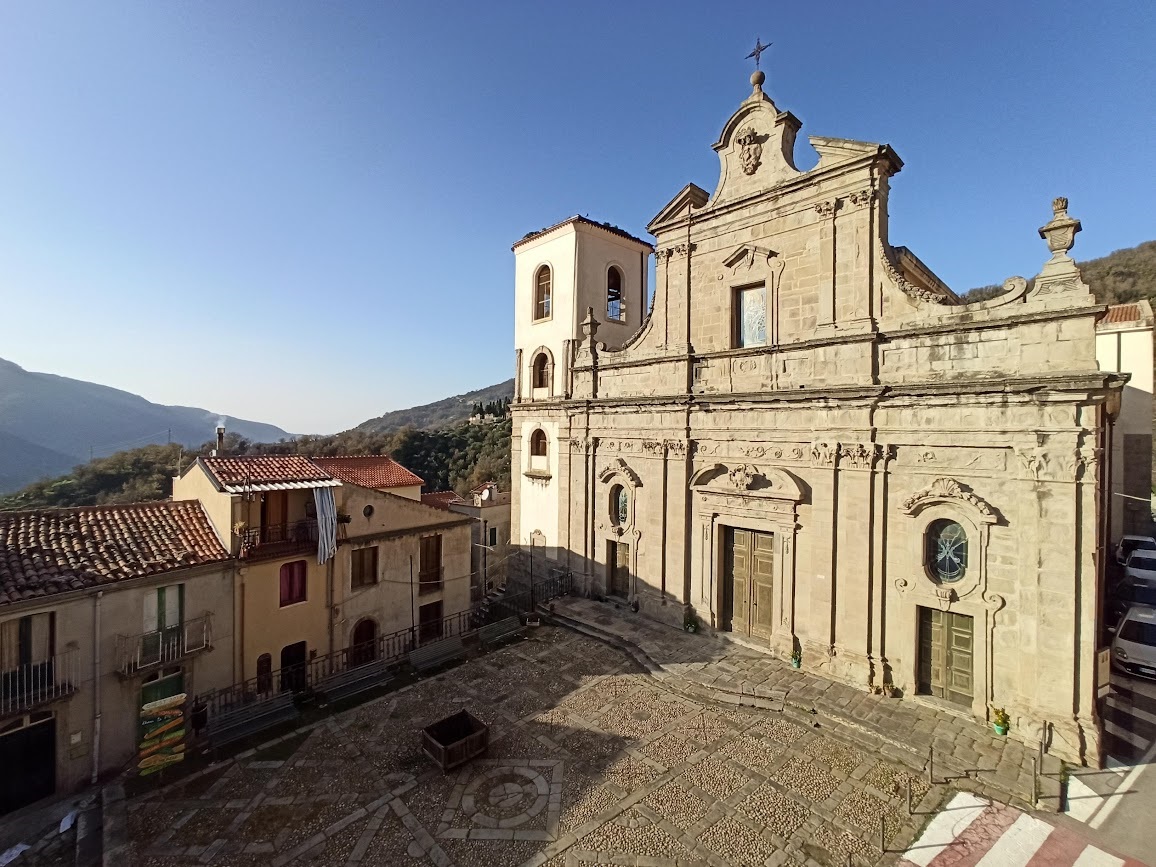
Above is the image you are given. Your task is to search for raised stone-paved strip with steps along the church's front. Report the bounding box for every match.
[545,598,1045,810]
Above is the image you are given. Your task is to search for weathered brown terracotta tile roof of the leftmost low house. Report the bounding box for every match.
[0,501,229,605]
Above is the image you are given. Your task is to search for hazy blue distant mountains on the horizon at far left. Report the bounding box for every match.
[0,358,292,494]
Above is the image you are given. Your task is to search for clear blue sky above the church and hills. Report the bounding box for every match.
[0,0,1156,432]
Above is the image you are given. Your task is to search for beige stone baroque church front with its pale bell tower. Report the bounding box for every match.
[512,72,1127,764]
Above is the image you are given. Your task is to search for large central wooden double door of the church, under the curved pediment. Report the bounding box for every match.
[721,527,775,637]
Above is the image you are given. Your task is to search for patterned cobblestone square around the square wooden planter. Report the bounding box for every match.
[117,627,944,867]
